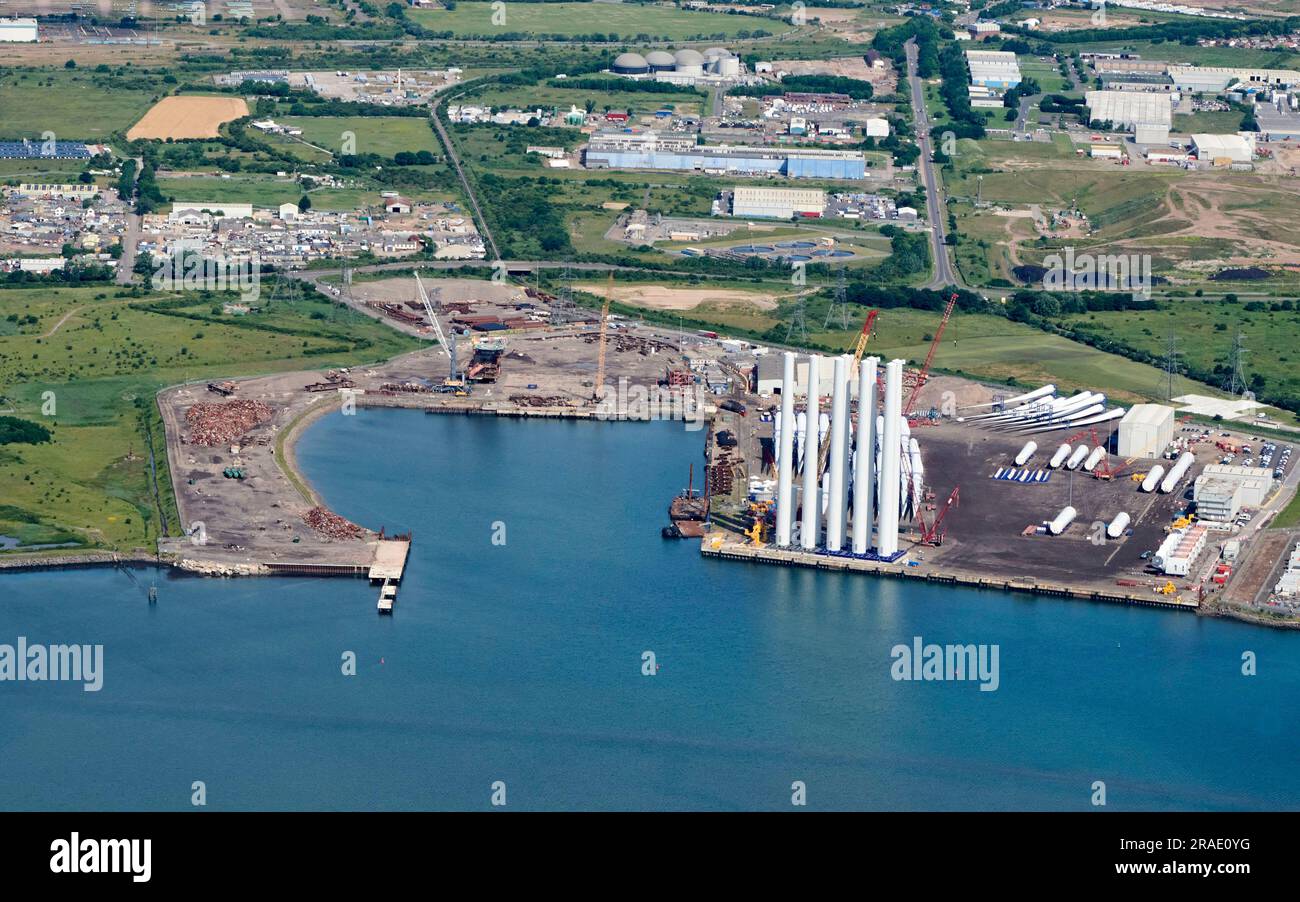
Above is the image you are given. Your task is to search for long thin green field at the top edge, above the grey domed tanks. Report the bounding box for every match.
[407,3,793,40]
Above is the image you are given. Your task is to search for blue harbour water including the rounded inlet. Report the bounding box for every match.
[0,409,1300,810]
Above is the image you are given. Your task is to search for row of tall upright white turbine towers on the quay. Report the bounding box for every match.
[776,351,922,560]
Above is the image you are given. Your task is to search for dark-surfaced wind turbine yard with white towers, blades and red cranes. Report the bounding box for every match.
[696,296,1297,616]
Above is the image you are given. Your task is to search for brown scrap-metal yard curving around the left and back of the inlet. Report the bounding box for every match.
[159,277,742,600]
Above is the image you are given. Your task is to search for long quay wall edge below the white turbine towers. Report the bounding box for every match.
[699,532,1200,611]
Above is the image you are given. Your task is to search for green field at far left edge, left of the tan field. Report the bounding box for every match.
[0,69,169,140]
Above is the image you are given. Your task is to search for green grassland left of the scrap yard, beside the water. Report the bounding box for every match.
[0,285,416,550]
